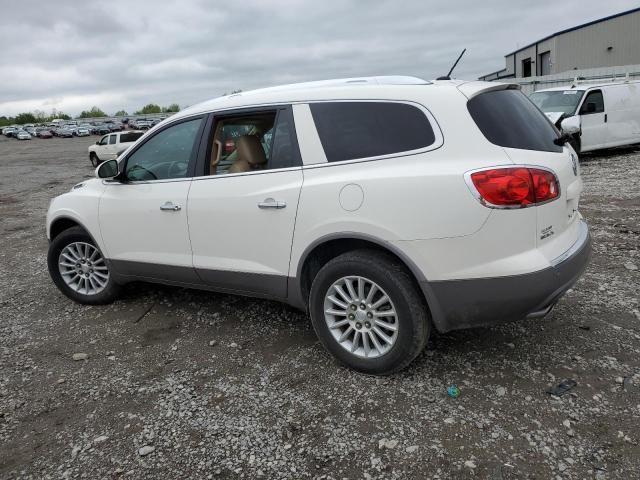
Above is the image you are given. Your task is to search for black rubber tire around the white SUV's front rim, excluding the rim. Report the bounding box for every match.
[47,227,121,305]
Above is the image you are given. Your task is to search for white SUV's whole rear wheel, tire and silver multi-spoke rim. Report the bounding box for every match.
[309,250,430,375]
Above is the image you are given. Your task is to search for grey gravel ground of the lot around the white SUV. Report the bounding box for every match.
[0,137,640,480]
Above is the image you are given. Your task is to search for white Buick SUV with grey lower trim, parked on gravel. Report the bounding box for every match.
[47,77,590,374]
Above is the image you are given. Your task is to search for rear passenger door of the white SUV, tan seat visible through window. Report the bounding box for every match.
[188,107,303,298]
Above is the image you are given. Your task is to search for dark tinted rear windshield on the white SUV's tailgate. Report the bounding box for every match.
[467,90,562,152]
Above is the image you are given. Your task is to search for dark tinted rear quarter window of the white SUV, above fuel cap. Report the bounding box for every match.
[309,102,435,162]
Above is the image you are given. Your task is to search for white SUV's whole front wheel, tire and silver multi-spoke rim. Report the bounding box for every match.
[47,227,120,305]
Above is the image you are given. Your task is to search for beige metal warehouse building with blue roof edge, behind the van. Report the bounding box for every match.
[479,8,640,80]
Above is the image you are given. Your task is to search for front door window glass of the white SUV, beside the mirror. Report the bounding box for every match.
[125,118,202,181]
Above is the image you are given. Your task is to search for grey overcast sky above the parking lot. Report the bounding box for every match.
[0,0,638,115]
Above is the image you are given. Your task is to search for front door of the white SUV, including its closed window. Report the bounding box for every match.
[99,116,206,283]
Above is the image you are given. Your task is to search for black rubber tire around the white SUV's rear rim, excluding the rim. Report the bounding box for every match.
[309,250,431,375]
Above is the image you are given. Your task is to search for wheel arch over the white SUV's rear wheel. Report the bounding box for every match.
[289,232,436,321]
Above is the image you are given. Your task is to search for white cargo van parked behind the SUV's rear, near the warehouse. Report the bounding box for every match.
[530,81,640,152]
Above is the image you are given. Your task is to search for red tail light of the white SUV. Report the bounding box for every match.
[467,167,560,208]
